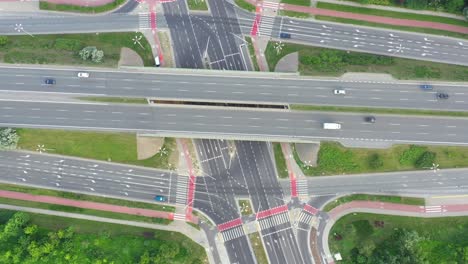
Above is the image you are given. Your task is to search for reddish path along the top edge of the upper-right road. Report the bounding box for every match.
[247,0,468,34]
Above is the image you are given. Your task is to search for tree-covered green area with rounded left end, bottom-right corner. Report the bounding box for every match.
[329,213,468,263]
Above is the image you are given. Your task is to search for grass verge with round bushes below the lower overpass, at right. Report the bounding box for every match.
[292,142,468,176]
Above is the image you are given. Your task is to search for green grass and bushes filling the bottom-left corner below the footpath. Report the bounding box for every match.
[0,210,208,263]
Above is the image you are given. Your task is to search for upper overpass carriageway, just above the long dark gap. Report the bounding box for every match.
[0,66,468,111]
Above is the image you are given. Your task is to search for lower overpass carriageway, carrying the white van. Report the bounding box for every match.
[4,101,468,146]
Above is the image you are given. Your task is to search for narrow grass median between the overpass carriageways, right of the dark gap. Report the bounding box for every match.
[289,104,468,117]
